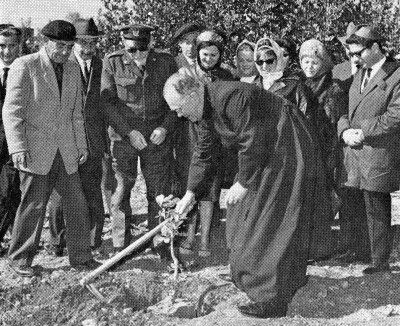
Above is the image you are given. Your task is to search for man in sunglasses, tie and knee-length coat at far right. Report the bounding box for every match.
[338,26,400,274]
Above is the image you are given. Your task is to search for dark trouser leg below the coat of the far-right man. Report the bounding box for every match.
[364,190,392,264]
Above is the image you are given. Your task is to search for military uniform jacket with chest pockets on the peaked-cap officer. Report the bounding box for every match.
[101,50,177,136]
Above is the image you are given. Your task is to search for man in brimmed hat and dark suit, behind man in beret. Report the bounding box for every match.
[49,18,107,256]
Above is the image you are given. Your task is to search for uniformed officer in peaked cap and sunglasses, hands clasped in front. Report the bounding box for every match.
[101,24,177,251]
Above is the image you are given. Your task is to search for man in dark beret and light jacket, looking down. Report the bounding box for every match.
[3,20,98,276]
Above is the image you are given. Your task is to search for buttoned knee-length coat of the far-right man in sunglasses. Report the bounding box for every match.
[338,59,400,192]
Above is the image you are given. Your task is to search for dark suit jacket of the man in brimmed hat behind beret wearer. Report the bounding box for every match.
[71,54,107,157]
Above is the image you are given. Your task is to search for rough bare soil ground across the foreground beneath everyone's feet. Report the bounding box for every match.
[0,180,400,326]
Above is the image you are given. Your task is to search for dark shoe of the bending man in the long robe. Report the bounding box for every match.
[238,301,287,318]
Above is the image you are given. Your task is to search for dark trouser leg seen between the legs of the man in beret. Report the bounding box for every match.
[47,189,65,247]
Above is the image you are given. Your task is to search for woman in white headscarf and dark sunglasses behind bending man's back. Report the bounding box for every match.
[254,38,310,111]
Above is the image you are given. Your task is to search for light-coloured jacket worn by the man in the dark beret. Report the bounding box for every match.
[3,48,87,175]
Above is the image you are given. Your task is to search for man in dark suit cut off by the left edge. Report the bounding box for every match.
[0,24,21,255]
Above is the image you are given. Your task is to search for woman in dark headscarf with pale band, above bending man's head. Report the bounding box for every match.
[177,30,234,257]
